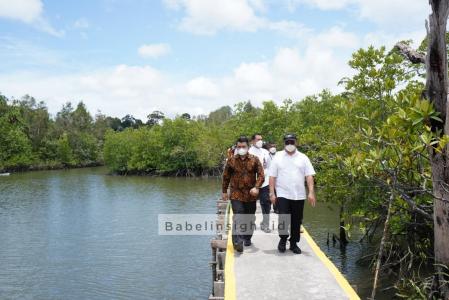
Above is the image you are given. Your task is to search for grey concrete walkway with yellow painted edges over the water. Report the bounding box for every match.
[209,201,360,300]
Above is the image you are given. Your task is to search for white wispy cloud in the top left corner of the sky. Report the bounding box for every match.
[0,0,64,37]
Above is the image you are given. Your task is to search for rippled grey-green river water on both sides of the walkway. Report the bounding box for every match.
[0,168,378,299]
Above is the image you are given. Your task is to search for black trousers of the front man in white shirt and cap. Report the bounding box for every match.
[277,197,305,244]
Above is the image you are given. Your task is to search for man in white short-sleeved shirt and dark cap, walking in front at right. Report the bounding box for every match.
[269,134,316,254]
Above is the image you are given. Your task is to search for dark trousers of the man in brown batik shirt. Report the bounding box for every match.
[231,200,256,244]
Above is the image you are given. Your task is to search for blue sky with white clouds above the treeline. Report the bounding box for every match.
[0,0,430,120]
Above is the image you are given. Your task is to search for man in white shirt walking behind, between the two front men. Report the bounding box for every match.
[248,133,271,233]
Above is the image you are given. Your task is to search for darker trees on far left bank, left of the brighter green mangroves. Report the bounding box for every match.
[0,95,120,171]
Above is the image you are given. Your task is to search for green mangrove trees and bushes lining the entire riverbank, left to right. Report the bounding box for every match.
[0,29,449,298]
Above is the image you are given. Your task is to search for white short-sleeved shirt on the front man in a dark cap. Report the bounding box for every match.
[270,150,315,200]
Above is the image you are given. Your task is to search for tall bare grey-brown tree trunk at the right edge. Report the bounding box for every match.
[426,0,449,299]
